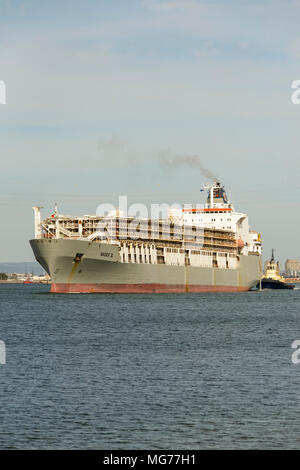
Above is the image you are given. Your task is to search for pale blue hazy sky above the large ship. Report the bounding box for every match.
[0,0,300,261]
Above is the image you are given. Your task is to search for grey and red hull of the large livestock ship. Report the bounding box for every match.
[30,239,261,293]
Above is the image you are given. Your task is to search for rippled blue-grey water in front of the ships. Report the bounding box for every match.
[0,285,300,449]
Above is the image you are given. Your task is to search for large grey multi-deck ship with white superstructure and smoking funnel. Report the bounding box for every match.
[30,181,262,293]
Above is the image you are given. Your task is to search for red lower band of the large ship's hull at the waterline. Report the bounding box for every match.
[51,284,249,294]
